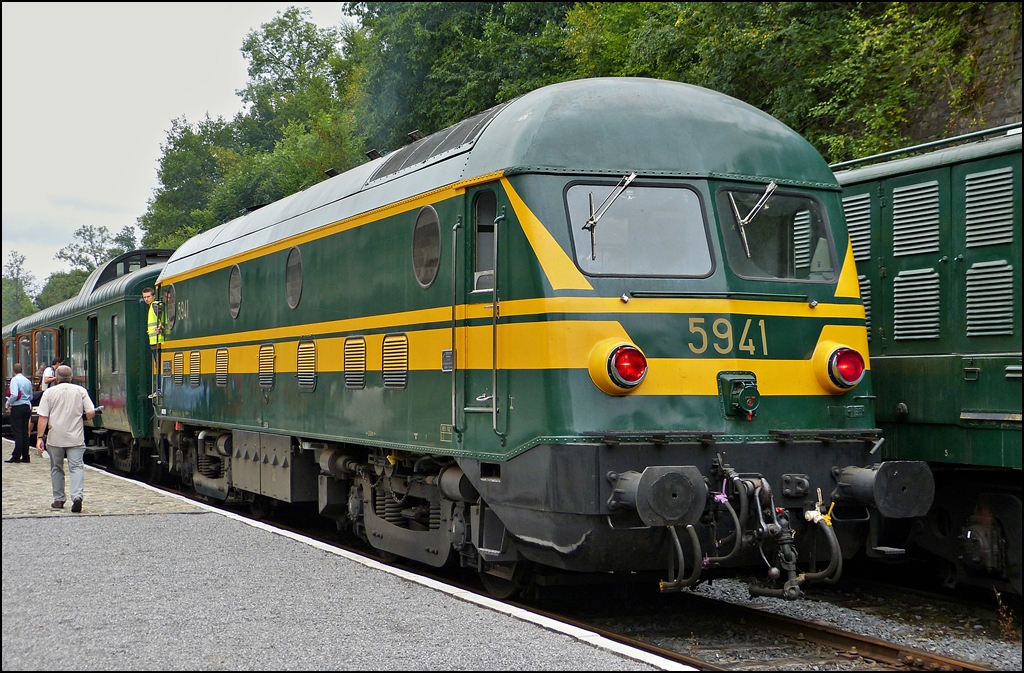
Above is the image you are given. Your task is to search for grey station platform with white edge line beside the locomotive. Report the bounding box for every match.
[2,439,692,671]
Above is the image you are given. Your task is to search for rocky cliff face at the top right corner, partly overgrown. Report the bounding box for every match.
[906,2,1021,142]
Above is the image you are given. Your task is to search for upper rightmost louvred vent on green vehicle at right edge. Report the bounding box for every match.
[967,166,1014,248]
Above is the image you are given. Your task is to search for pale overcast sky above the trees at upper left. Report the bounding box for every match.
[3,2,348,289]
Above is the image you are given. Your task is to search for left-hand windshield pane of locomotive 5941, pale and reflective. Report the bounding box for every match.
[565,184,712,277]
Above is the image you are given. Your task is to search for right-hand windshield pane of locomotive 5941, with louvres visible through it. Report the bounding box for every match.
[718,185,836,282]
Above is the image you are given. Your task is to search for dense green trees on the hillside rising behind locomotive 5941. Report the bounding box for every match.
[138,2,1021,247]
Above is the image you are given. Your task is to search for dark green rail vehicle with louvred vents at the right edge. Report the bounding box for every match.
[835,123,1021,594]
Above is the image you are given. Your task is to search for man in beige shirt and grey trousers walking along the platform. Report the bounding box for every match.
[36,365,96,512]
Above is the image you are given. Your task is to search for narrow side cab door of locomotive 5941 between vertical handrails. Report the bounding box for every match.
[453,187,509,452]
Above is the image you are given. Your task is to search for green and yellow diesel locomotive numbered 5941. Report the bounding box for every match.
[144,79,933,597]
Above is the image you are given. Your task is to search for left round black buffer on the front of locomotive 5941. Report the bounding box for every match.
[608,465,708,525]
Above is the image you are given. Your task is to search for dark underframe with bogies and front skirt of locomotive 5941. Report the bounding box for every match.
[153,424,937,594]
